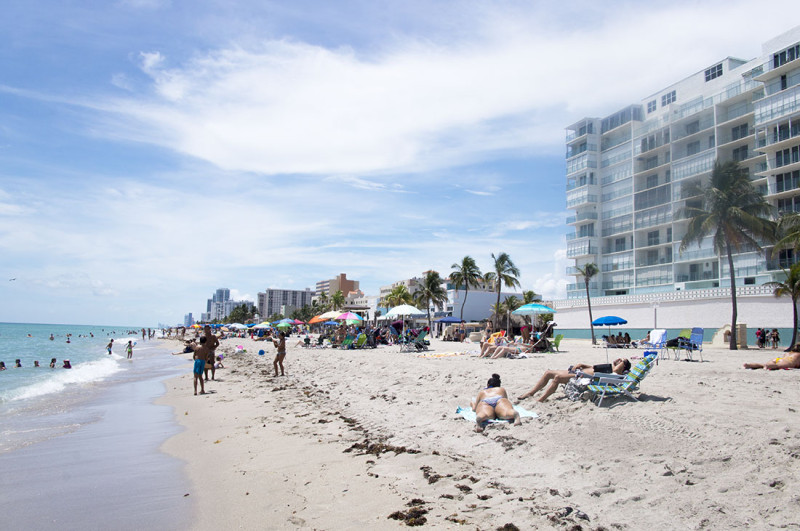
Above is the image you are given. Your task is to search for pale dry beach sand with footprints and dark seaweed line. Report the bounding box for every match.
[160,337,800,530]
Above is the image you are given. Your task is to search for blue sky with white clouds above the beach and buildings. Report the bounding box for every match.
[0,0,796,326]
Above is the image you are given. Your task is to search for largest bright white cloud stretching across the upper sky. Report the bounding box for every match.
[90,1,789,179]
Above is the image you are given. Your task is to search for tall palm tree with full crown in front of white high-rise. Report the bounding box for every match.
[679,161,776,350]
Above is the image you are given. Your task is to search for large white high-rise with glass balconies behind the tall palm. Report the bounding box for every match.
[566,27,800,298]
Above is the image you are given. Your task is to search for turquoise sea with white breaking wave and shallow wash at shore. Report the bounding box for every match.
[0,323,191,529]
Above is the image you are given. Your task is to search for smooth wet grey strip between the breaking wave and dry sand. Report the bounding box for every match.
[0,345,190,530]
